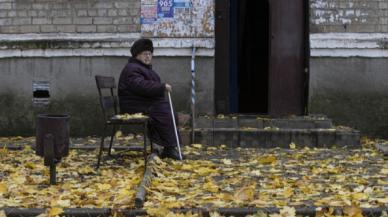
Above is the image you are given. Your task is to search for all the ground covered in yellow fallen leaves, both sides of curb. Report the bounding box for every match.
[0,135,388,216]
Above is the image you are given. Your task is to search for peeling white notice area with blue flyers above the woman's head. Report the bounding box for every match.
[142,0,214,37]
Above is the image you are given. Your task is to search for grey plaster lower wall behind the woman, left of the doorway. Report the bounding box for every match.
[0,57,214,136]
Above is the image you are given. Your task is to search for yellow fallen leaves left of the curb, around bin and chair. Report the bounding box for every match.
[0,146,144,210]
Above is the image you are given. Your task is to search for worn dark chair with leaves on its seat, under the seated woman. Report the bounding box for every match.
[95,75,152,169]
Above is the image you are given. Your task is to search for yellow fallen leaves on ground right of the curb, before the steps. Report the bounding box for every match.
[145,144,388,212]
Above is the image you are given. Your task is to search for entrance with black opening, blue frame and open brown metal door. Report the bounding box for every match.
[214,0,309,116]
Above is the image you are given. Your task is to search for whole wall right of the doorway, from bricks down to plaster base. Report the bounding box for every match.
[309,0,388,138]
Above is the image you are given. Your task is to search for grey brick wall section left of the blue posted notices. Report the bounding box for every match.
[0,0,140,33]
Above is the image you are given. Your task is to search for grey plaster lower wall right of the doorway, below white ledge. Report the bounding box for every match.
[310,57,388,138]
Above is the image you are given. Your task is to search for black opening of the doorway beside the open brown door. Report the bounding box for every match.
[230,0,270,114]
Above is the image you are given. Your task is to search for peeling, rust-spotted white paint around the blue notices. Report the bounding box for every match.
[141,0,214,37]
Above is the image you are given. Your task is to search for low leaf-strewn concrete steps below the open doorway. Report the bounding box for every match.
[182,115,360,148]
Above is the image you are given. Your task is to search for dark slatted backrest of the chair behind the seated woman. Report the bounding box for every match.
[95,75,118,119]
